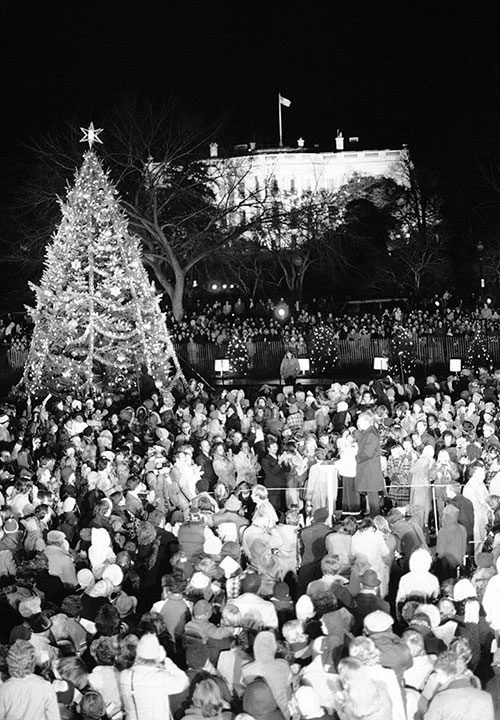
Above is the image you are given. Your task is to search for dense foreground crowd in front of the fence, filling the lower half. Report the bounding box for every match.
[0,368,500,720]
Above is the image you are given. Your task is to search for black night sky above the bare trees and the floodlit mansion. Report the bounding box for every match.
[0,0,500,268]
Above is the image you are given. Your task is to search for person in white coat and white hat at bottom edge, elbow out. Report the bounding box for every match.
[120,633,188,720]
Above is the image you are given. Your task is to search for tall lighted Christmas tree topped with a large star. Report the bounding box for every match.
[23,125,182,396]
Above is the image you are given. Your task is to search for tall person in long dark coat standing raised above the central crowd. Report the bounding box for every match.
[354,413,385,517]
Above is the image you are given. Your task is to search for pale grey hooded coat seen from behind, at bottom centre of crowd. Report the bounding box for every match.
[242,630,292,718]
